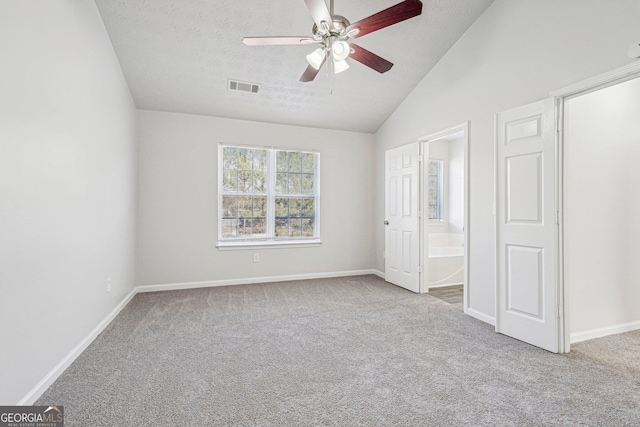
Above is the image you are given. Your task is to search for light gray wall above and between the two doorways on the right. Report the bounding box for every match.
[375,0,640,321]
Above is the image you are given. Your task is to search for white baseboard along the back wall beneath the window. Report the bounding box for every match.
[136,270,377,293]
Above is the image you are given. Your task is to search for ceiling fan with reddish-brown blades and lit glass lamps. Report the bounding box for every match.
[242,0,422,82]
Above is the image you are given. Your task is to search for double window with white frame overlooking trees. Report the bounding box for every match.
[218,145,320,246]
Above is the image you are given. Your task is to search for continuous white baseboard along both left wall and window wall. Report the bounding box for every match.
[17,269,380,406]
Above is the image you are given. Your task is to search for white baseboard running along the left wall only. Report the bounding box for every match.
[17,288,138,406]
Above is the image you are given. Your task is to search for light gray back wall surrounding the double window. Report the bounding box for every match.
[138,111,375,285]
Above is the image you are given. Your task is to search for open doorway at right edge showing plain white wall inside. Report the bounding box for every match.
[562,77,640,343]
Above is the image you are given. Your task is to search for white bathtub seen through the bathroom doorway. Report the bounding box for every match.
[427,236,464,288]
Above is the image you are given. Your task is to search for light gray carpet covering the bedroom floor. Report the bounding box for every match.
[37,276,640,426]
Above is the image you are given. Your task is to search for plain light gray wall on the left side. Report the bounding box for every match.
[0,0,136,405]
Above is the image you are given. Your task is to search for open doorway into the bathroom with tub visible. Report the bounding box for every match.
[421,123,469,312]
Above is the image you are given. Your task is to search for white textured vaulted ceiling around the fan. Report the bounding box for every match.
[96,0,493,133]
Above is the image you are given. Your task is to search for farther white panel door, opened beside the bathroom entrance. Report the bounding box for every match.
[384,142,420,292]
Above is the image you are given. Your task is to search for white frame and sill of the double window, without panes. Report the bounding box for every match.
[216,143,322,250]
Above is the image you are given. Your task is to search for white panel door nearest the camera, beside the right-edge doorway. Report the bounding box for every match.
[496,99,559,353]
